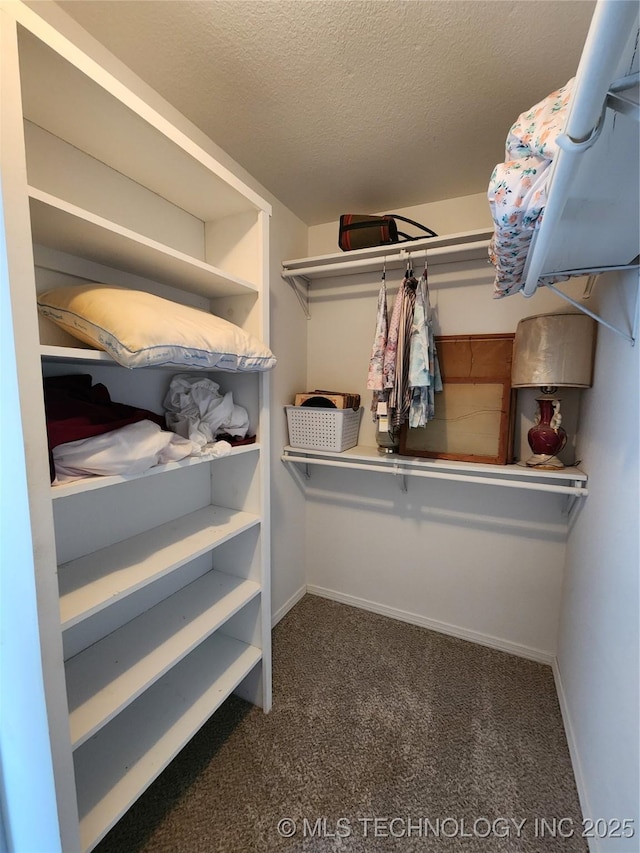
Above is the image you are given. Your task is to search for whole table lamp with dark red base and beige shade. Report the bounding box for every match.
[511,314,596,471]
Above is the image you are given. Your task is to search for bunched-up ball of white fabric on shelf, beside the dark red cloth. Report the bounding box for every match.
[163,373,249,455]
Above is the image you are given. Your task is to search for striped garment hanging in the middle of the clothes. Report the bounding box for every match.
[385,270,418,427]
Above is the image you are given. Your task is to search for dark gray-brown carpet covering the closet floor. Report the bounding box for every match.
[96,595,587,853]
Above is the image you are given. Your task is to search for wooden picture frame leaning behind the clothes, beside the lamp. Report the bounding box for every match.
[400,334,516,465]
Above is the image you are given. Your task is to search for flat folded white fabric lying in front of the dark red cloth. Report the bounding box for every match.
[52,421,193,485]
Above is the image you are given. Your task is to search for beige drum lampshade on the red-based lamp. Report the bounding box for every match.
[511,314,596,388]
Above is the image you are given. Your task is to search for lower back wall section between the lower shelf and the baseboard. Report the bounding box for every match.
[307,467,566,663]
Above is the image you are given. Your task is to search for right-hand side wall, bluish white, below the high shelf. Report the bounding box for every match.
[557,272,640,853]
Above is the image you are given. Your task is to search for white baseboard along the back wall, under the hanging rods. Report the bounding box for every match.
[307,584,555,666]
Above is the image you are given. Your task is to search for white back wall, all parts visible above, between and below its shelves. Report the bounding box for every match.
[306,195,582,661]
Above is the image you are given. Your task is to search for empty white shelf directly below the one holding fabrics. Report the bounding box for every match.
[58,506,260,631]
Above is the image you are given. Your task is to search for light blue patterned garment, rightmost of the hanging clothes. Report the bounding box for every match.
[409,266,442,428]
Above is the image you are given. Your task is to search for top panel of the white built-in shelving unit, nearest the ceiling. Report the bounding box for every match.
[16,25,271,222]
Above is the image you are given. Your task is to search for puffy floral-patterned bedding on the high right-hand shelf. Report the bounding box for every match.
[488,80,573,299]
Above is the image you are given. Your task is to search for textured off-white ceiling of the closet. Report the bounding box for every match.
[53,0,594,224]
